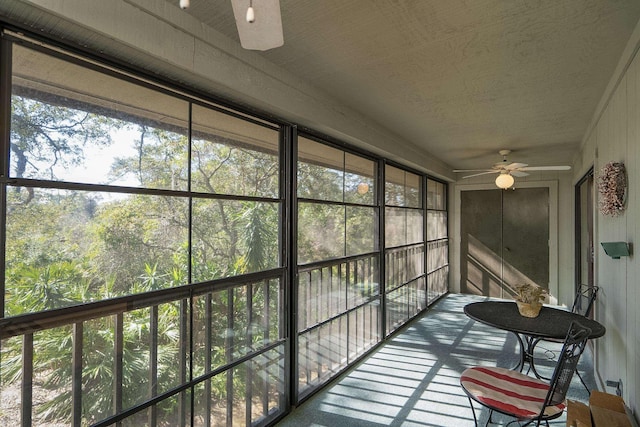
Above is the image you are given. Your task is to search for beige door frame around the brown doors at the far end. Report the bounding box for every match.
[449,181,559,304]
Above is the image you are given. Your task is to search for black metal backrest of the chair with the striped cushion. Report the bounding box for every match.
[544,322,591,407]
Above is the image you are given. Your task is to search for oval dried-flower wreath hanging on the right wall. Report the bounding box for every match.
[598,162,627,216]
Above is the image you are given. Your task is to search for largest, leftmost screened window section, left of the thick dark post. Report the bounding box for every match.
[0,36,284,426]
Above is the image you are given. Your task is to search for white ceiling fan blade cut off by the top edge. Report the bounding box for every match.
[231,0,284,50]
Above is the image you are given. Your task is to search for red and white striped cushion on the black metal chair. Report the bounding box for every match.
[460,366,565,419]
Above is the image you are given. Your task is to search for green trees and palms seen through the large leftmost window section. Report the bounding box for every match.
[0,96,280,423]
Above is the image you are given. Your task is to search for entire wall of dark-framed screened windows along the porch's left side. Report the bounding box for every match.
[0,27,448,427]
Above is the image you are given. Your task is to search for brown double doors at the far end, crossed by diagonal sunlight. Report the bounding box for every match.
[460,188,549,298]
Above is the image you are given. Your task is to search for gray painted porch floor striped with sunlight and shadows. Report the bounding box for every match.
[277,294,595,427]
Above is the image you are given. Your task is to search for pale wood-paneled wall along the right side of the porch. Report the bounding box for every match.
[575,20,640,419]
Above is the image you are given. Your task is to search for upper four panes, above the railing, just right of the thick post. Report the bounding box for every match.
[297,137,378,264]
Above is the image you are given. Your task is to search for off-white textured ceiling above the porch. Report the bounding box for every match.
[181,0,640,172]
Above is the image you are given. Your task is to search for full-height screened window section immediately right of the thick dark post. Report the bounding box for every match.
[297,137,381,397]
